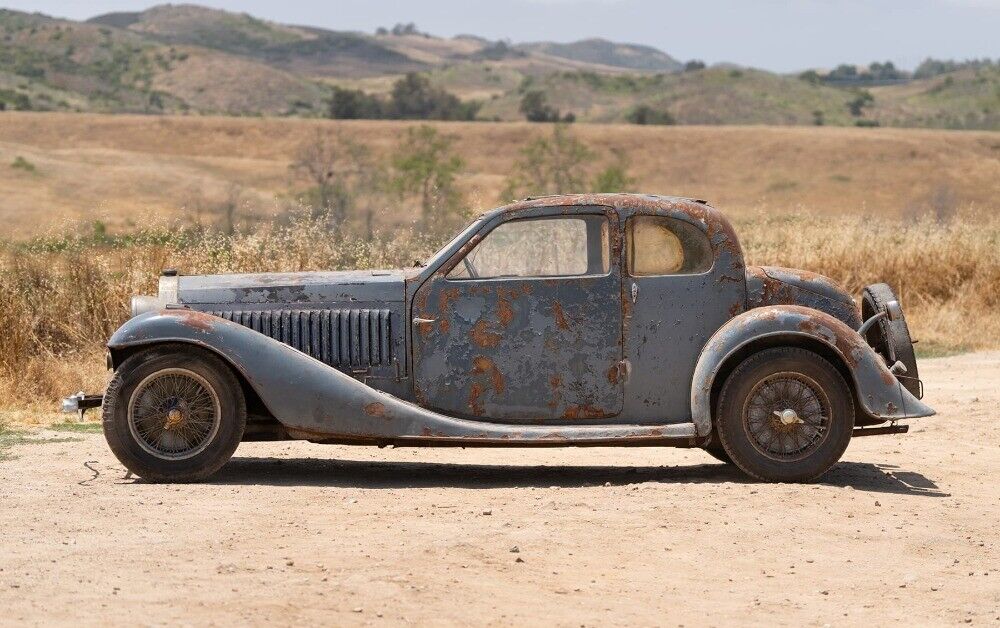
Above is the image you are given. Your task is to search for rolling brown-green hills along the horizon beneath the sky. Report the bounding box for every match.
[0,5,1000,129]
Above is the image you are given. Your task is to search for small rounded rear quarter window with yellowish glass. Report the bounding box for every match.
[626,216,713,277]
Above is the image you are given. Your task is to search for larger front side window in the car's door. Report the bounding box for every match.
[448,216,611,279]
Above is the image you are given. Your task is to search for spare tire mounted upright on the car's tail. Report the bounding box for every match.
[861,283,920,397]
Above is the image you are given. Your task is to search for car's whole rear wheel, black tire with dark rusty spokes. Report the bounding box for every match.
[715,347,854,482]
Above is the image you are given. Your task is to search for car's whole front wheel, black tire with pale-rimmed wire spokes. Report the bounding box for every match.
[103,344,247,482]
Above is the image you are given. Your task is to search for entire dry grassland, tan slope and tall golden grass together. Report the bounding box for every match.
[0,113,1000,412]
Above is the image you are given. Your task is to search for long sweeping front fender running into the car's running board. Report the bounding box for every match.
[108,310,696,446]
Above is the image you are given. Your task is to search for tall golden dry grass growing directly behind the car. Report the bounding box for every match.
[0,212,1000,408]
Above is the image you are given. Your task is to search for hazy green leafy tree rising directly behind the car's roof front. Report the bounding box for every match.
[501,124,593,200]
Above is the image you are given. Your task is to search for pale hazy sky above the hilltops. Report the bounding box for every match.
[7,0,1000,71]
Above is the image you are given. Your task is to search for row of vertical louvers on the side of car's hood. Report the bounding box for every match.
[211,309,394,370]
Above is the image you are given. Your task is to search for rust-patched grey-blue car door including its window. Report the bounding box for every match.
[412,207,623,422]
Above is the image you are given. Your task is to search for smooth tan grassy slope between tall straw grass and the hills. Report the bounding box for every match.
[0,112,1000,239]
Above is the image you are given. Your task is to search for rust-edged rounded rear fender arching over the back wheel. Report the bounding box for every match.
[691,305,934,436]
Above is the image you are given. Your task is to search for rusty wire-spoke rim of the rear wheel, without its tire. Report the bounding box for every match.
[743,372,831,462]
